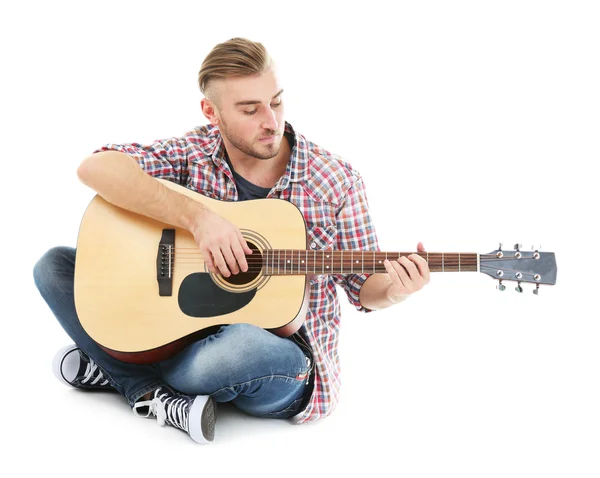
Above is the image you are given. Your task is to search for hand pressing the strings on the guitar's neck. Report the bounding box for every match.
[383,242,429,304]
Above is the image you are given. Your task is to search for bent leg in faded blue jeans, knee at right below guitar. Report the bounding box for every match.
[158,324,312,418]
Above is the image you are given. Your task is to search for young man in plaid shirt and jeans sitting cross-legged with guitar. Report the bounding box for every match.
[34,38,429,443]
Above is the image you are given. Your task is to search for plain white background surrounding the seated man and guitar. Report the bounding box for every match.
[0,0,600,477]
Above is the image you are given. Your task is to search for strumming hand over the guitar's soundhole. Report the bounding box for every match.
[190,209,252,277]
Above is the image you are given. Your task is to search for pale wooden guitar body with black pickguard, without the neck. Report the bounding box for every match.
[75,179,309,363]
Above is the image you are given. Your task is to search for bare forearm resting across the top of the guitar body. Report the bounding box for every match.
[77,151,206,230]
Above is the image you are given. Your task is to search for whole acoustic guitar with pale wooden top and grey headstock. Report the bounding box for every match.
[75,179,557,363]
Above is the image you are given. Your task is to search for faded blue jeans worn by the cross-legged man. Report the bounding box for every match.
[33,247,311,418]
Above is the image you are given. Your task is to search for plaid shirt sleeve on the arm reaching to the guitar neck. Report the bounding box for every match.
[333,175,379,312]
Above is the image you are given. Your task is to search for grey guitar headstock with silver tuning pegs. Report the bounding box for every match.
[479,244,556,294]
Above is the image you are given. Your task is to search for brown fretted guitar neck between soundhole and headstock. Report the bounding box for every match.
[263,249,479,275]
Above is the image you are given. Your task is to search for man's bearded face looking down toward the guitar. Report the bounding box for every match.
[213,68,285,159]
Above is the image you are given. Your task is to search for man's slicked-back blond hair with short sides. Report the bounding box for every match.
[198,38,272,99]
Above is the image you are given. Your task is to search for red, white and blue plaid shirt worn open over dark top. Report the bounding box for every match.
[94,123,379,423]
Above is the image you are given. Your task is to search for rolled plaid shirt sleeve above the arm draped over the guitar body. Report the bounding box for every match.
[94,137,188,184]
